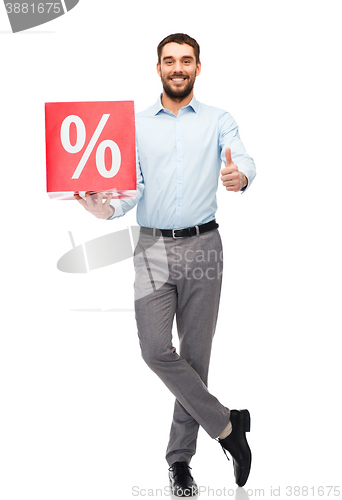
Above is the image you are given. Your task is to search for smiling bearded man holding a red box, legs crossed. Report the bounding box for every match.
[75,33,255,496]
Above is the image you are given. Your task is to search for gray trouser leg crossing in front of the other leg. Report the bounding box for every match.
[135,229,229,448]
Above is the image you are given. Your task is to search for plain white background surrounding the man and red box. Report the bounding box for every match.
[0,0,342,500]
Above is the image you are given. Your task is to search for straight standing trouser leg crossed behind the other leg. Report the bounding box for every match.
[166,231,224,464]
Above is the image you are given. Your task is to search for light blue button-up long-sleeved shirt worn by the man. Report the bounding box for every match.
[111,97,256,229]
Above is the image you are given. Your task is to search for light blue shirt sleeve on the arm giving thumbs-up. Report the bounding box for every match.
[219,112,256,192]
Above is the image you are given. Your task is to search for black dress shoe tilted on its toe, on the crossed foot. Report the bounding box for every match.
[218,410,252,486]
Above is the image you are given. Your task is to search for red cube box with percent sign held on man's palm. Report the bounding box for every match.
[45,101,136,200]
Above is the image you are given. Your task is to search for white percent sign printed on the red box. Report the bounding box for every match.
[61,115,121,179]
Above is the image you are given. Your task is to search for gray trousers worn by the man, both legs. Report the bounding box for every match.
[134,229,230,465]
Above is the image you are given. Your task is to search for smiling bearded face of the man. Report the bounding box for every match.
[157,42,201,99]
